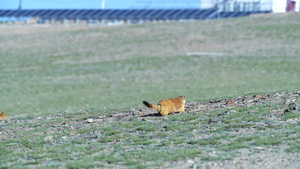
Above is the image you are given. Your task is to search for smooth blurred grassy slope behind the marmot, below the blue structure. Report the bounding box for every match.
[0,14,300,115]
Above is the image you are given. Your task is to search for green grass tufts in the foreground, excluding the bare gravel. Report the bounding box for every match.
[0,103,300,168]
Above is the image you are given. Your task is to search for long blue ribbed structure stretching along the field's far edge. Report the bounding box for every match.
[0,8,271,23]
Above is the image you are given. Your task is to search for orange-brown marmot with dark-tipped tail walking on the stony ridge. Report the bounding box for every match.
[143,96,186,116]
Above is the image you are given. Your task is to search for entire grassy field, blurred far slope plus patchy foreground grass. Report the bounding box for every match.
[0,13,300,168]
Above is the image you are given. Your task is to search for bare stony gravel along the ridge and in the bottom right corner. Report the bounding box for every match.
[0,91,300,168]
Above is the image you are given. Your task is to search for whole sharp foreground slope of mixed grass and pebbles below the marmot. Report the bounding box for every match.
[0,93,300,168]
